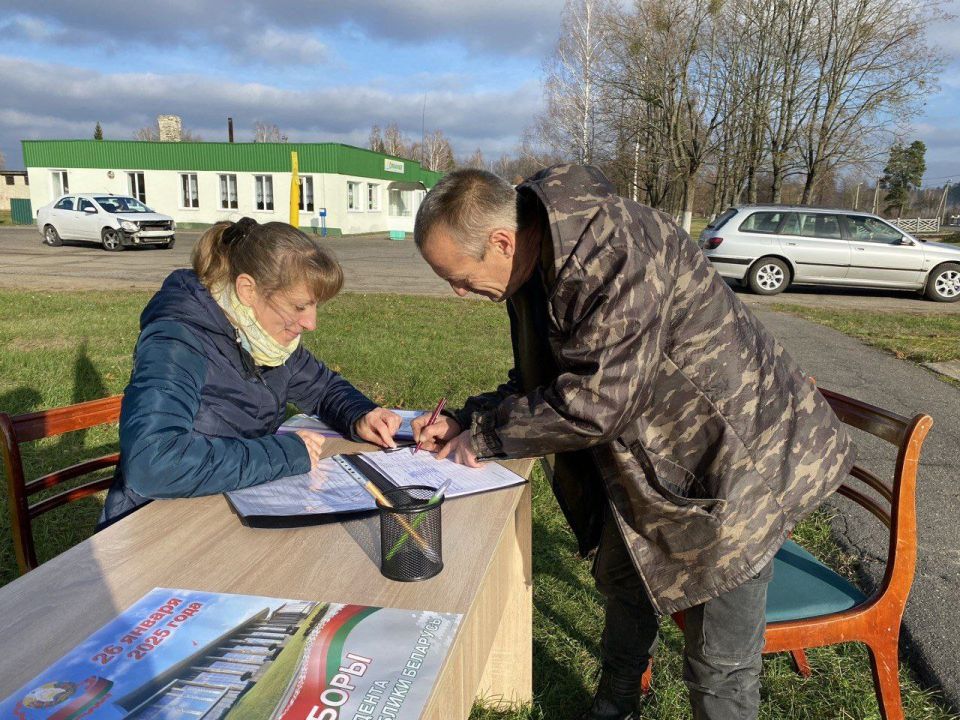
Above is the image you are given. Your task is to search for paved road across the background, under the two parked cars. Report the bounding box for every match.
[0,227,960,313]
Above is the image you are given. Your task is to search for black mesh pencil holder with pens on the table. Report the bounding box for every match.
[377,485,443,582]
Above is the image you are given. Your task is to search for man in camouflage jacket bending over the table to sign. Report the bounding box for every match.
[414,165,854,720]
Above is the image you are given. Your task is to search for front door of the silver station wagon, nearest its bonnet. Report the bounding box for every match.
[844,215,923,288]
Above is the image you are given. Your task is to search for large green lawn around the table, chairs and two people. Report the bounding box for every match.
[0,291,950,720]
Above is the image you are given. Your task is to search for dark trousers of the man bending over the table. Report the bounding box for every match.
[593,517,773,720]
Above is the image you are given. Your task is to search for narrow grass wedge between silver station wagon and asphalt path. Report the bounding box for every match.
[773,304,960,362]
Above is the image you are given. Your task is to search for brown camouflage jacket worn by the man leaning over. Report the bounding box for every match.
[460,166,855,613]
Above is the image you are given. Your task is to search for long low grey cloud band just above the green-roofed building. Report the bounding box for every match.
[0,56,541,167]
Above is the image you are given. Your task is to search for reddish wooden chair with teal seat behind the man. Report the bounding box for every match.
[641,389,933,720]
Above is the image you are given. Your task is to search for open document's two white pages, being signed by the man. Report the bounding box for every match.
[227,448,525,517]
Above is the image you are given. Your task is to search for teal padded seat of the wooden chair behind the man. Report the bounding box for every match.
[767,540,867,623]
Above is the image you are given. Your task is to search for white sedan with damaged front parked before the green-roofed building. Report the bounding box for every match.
[37,193,177,250]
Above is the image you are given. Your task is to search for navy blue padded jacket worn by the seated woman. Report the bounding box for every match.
[100,270,377,528]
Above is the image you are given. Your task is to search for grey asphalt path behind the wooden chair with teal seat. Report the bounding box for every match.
[757,309,960,710]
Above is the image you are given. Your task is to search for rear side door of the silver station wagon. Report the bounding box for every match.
[779,212,850,282]
